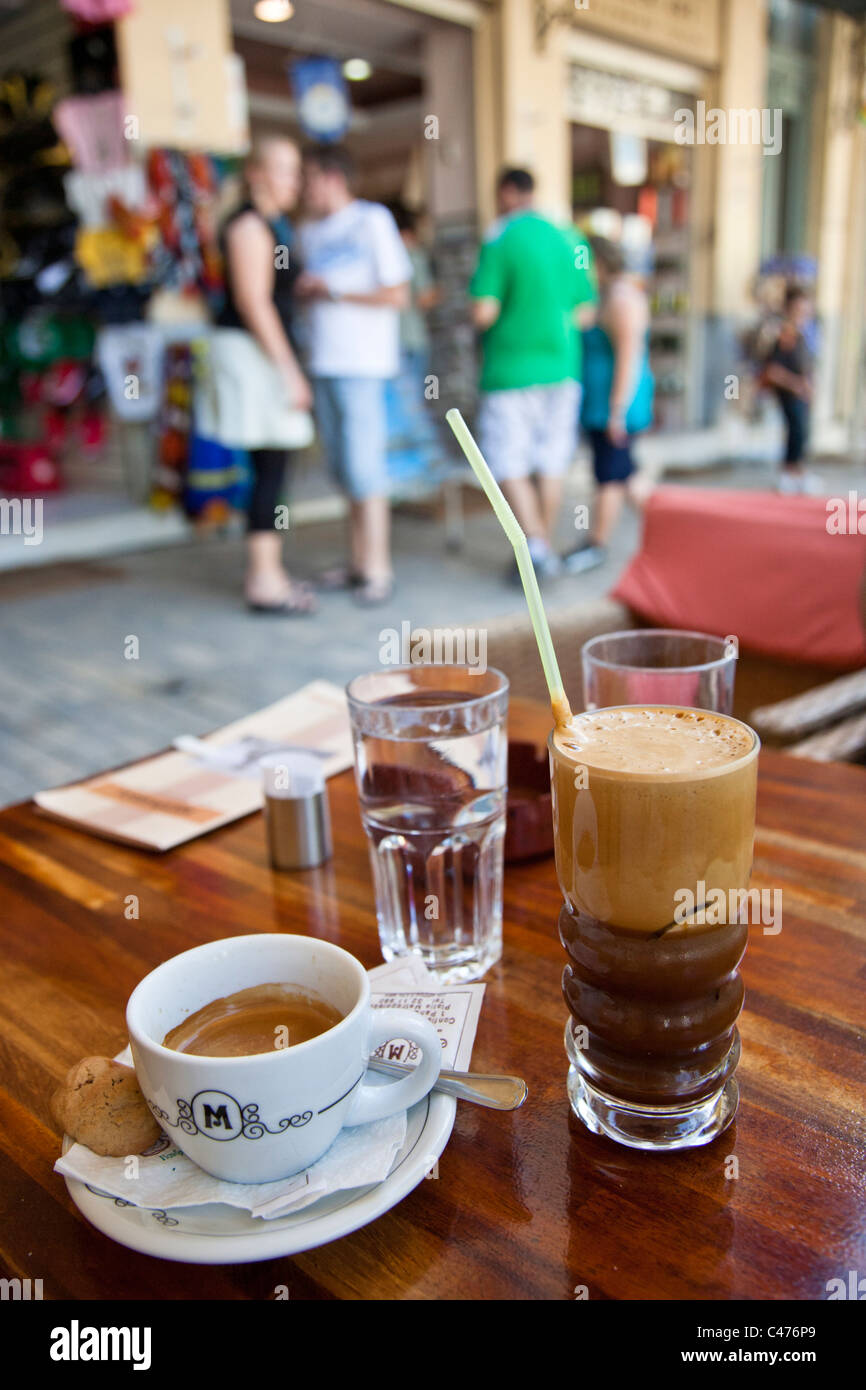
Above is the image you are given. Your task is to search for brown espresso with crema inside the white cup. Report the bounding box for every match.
[163,983,343,1056]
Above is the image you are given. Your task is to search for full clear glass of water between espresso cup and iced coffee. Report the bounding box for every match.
[346,664,509,984]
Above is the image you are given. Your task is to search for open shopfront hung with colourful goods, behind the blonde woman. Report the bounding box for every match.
[0,0,475,562]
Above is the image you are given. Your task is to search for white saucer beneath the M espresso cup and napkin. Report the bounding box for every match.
[64,1091,457,1265]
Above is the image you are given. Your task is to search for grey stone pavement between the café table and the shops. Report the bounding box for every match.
[0,464,862,805]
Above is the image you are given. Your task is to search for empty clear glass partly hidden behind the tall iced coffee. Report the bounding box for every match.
[581,627,737,714]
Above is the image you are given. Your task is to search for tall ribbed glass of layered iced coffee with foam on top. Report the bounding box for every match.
[549,706,759,1148]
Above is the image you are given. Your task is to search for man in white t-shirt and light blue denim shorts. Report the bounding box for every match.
[297,145,411,603]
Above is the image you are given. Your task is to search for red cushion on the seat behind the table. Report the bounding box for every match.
[612,487,866,670]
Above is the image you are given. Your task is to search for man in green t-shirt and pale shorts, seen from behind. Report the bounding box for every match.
[470,168,595,578]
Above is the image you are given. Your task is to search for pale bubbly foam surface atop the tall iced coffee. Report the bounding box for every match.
[555,706,755,777]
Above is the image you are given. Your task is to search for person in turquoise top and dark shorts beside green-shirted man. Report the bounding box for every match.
[563,236,653,574]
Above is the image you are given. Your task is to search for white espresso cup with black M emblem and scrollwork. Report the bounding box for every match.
[126,934,442,1183]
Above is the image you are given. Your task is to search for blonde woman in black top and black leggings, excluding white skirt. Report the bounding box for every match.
[218,136,316,613]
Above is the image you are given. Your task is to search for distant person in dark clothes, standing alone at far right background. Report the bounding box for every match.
[762,285,815,492]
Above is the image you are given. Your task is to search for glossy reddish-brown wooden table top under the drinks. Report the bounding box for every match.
[0,701,866,1300]
